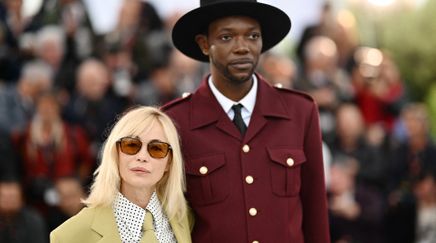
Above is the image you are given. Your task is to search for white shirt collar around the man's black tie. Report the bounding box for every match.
[208,75,258,114]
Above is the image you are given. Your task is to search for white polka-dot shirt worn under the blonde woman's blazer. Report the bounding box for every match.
[113,192,177,243]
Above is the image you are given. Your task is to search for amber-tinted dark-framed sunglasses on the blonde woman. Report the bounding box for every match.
[117,137,172,159]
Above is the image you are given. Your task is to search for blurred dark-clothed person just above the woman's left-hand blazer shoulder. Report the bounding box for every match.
[46,176,86,232]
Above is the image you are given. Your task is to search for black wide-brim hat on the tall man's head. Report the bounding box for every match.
[172,0,291,62]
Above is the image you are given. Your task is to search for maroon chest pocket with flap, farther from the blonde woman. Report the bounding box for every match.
[268,148,306,197]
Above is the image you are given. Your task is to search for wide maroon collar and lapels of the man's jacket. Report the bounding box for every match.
[190,74,291,141]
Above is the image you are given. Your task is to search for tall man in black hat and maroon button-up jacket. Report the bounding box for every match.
[162,0,330,243]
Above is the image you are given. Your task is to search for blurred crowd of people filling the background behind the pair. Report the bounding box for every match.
[0,0,436,243]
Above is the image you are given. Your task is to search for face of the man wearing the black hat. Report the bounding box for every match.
[196,16,262,84]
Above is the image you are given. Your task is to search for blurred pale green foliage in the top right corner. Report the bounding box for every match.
[352,0,436,138]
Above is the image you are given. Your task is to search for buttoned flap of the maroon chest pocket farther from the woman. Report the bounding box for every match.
[267,148,306,167]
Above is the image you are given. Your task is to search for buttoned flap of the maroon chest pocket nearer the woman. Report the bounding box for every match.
[185,154,225,176]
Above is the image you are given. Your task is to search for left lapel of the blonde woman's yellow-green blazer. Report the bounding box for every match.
[91,207,121,243]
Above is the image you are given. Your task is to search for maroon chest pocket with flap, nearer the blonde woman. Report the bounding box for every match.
[185,154,229,206]
